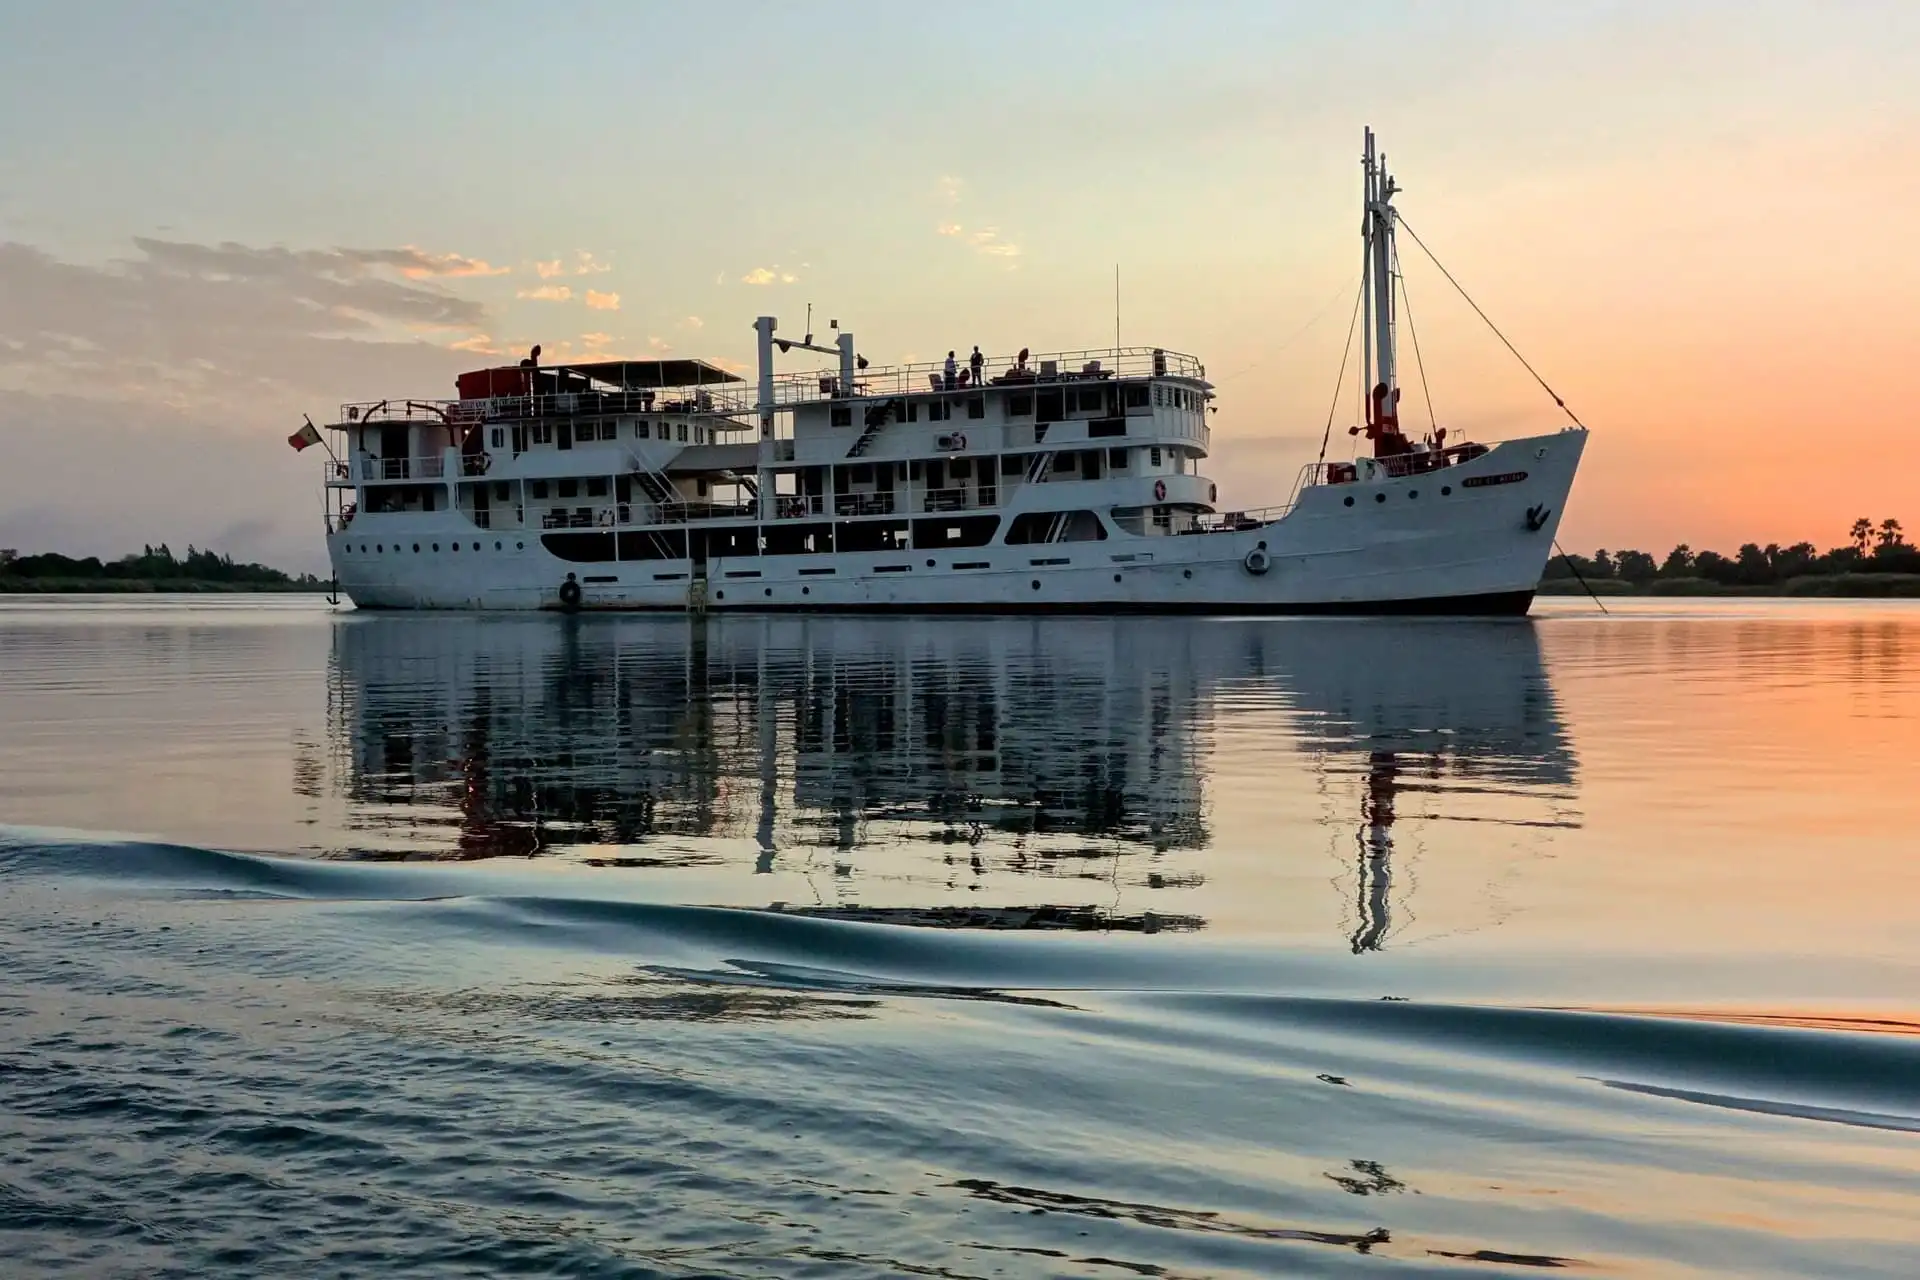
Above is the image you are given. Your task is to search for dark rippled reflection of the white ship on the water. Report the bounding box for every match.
[322,616,1576,936]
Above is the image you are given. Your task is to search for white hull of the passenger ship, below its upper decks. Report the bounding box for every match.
[328,430,1586,614]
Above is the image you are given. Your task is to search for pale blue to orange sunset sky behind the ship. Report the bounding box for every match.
[0,0,1920,570]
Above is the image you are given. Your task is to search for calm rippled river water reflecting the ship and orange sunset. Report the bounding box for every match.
[0,599,1920,1278]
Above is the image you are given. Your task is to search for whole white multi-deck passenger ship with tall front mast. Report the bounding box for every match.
[303,129,1588,614]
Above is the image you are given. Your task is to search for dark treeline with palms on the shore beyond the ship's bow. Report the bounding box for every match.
[1542,520,1920,595]
